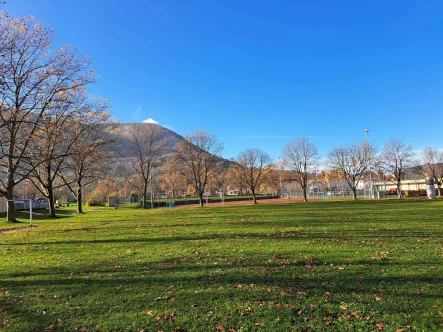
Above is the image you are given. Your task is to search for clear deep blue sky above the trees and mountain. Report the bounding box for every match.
[6,0,443,158]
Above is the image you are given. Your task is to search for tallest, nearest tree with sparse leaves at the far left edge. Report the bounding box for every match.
[0,12,94,222]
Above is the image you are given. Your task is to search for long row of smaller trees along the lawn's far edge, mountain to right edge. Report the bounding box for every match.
[116,124,443,205]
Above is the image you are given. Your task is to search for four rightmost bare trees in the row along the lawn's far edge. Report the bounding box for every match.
[283,138,443,201]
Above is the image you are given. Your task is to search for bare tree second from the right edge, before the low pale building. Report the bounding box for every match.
[380,138,417,198]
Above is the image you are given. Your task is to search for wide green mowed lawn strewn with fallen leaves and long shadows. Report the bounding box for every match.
[0,199,443,331]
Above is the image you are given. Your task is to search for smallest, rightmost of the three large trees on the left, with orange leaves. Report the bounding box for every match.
[58,107,117,213]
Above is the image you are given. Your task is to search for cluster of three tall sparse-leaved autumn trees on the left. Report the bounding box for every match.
[0,12,114,222]
